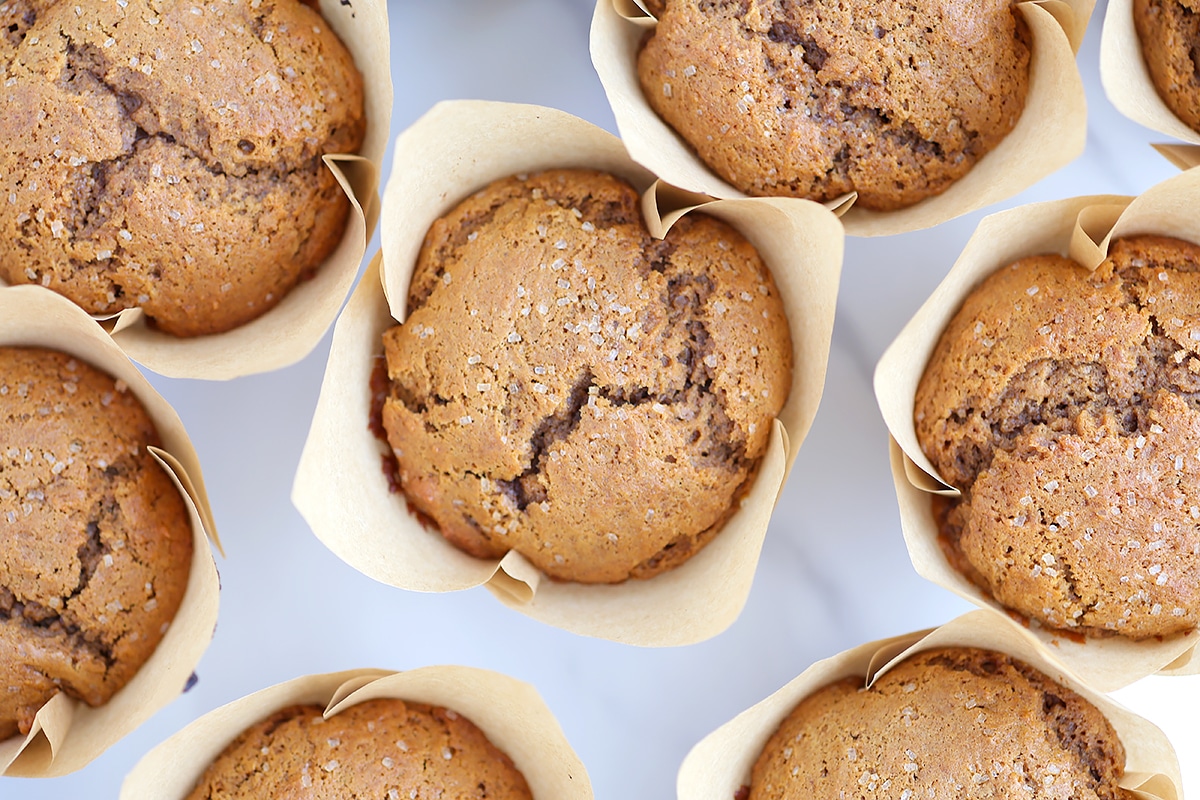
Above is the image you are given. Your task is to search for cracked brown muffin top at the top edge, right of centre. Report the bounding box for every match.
[637,0,1031,211]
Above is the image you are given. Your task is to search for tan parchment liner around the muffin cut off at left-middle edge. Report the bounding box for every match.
[0,287,221,777]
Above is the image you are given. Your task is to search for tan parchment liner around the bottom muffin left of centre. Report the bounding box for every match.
[120,667,592,800]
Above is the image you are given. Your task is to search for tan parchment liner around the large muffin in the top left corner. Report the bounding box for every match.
[0,0,392,380]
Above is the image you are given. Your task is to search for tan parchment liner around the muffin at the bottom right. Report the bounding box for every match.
[677,610,1183,800]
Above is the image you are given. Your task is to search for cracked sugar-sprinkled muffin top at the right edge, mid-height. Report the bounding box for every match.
[916,236,1200,639]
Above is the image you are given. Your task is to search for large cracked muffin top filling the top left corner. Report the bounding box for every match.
[0,0,365,336]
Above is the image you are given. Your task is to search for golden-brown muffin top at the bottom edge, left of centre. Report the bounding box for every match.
[185,699,533,800]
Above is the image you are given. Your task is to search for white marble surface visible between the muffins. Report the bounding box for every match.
[0,0,1200,800]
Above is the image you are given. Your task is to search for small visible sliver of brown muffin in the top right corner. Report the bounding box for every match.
[1133,0,1200,132]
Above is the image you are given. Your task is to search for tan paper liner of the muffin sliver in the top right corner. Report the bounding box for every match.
[1100,0,1200,145]
